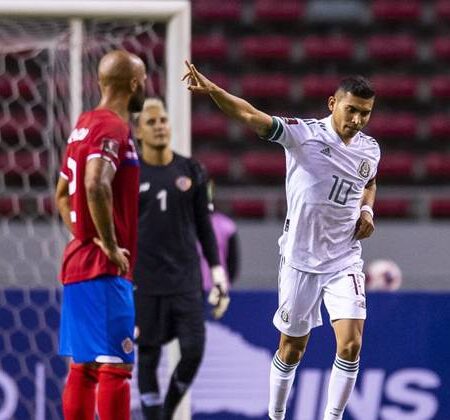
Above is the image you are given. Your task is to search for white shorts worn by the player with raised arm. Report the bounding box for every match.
[273,258,366,337]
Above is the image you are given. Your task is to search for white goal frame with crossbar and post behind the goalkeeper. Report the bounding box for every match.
[0,0,191,155]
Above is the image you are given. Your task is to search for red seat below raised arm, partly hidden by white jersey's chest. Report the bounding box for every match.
[240,150,286,181]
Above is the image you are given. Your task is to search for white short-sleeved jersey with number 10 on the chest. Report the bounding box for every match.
[267,116,380,273]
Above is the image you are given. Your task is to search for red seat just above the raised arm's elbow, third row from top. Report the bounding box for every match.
[241,74,291,99]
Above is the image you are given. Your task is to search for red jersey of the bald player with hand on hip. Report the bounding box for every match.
[61,109,139,284]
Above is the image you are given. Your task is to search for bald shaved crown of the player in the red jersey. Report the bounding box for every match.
[98,50,145,89]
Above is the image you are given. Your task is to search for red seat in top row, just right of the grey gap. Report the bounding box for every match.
[372,0,422,22]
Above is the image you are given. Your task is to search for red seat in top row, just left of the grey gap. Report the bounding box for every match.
[254,0,304,22]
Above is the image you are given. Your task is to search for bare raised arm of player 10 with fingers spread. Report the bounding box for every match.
[183,61,272,137]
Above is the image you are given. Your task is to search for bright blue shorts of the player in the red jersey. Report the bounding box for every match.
[59,276,134,363]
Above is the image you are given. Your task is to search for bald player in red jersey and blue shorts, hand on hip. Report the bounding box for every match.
[55,50,146,420]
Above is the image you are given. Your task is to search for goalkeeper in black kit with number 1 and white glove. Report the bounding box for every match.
[135,98,229,420]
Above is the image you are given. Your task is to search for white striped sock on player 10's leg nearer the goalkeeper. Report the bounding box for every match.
[269,351,298,420]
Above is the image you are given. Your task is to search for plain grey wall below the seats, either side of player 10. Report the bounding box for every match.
[235,222,450,290]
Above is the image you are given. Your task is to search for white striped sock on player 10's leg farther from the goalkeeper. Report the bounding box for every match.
[323,355,359,420]
